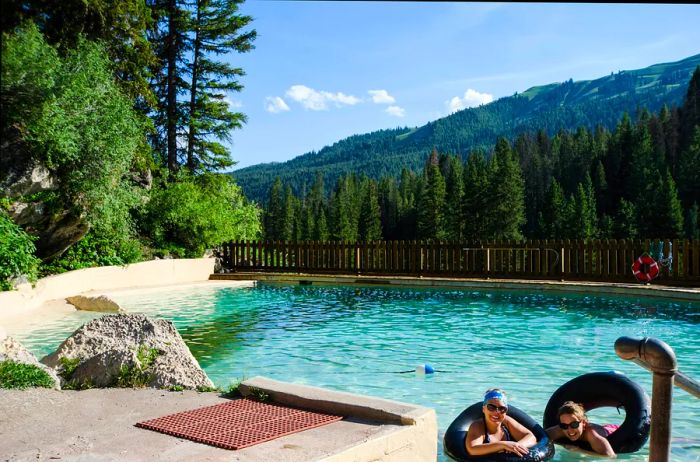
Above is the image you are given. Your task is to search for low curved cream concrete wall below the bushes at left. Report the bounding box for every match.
[0,258,214,319]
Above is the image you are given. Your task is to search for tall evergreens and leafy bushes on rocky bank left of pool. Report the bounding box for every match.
[0,0,260,290]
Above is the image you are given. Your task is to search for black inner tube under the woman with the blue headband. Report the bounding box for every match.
[443,401,554,462]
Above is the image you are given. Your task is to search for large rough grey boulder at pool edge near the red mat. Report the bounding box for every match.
[41,314,214,389]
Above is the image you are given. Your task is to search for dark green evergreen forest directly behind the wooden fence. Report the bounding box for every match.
[264,67,700,241]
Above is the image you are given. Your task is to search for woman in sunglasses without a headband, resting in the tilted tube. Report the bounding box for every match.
[547,401,617,458]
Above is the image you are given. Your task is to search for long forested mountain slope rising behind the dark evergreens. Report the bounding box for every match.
[232,54,700,203]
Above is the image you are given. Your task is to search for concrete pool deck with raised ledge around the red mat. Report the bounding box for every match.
[0,377,437,462]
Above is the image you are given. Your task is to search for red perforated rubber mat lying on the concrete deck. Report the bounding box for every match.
[136,399,342,449]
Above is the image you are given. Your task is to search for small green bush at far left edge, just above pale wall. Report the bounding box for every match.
[0,210,39,290]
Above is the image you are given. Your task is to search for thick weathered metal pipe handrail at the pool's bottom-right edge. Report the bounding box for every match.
[615,337,700,462]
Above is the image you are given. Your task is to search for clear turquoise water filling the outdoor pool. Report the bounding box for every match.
[11,284,700,462]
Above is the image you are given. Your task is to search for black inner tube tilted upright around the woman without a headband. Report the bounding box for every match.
[542,371,651,454]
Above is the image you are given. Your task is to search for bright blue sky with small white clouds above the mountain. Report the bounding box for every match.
[226,0,700,170]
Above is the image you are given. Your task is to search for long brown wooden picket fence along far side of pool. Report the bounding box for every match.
[223,239,700,286]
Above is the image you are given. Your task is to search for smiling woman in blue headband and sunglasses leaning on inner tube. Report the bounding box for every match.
[465,388,537,457]
